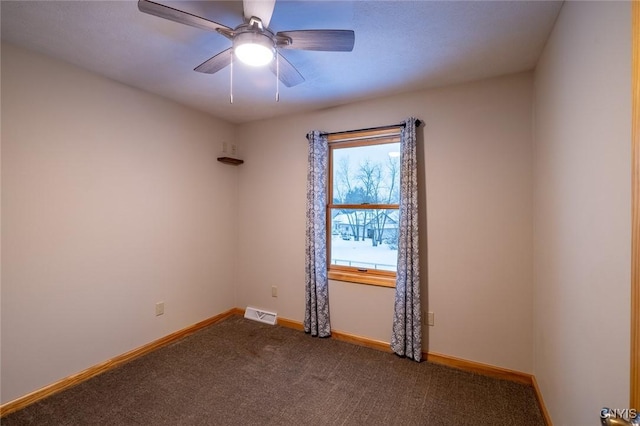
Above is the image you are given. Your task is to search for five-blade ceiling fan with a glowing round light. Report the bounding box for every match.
[138,0,355,87]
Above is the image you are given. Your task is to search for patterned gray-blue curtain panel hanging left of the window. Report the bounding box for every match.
[304,130,331,337]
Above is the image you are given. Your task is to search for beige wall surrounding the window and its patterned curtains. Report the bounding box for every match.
[237,73,533,372]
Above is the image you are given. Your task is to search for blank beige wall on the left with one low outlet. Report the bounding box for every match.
[1,44,238,402]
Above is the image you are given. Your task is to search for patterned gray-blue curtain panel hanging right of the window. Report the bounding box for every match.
[391,118,422,362]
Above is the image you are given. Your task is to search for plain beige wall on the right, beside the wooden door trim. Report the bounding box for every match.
[534,2,631,425]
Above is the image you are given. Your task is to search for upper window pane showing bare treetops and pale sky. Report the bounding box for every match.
[332,143,400,204]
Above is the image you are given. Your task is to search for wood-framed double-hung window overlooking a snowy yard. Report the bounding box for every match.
[327,127,400,287]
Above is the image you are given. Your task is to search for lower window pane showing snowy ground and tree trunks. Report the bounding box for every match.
[330,209,398,272]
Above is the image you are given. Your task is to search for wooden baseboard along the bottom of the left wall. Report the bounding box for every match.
[0,308,238,417]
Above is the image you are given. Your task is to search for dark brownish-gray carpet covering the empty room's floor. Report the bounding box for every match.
[1,316,544,426]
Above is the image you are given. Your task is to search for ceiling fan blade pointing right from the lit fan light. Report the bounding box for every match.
[276,30,356,52]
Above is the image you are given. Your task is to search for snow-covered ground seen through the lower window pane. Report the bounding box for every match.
[331,235,398,271]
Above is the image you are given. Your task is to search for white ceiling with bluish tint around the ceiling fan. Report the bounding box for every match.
[0,0,562,123]
